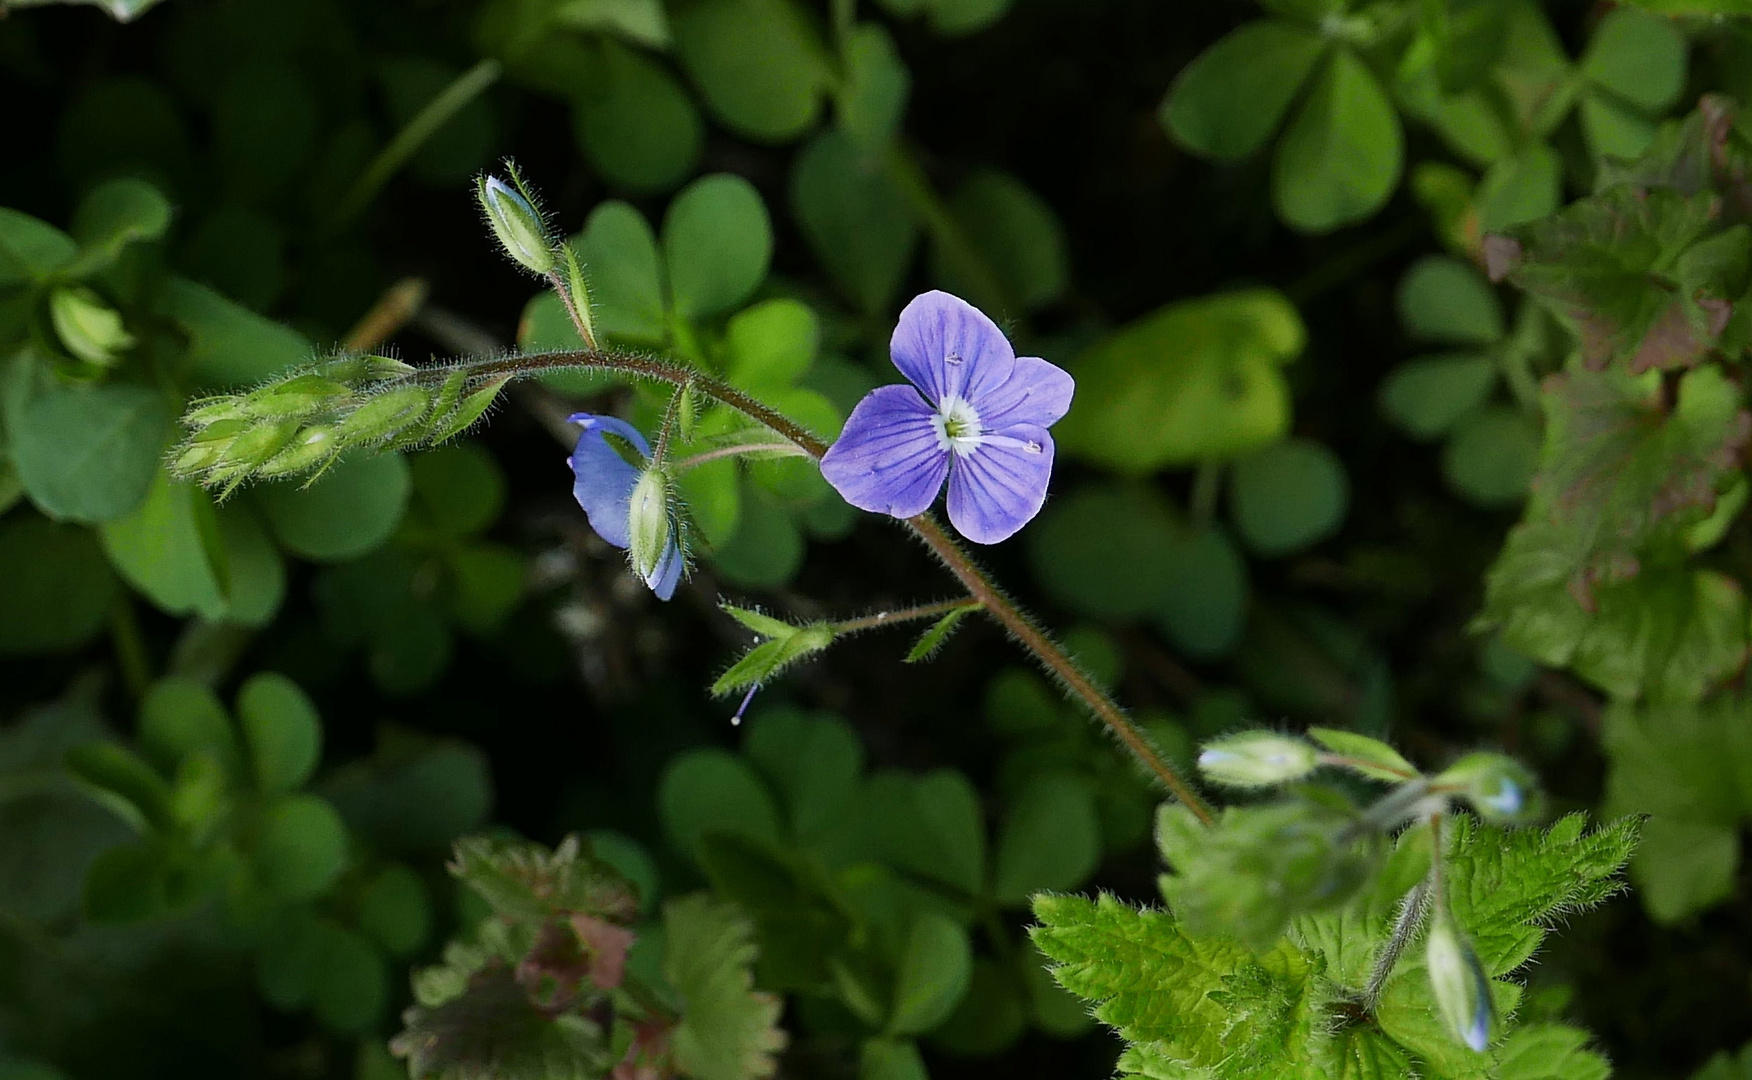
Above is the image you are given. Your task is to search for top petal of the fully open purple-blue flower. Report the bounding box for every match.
[888,291,1016,405]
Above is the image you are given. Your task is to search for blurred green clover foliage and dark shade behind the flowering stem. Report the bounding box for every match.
[0,0,1752,1080]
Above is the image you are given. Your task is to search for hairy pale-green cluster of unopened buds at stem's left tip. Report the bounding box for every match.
[170,356,506,491]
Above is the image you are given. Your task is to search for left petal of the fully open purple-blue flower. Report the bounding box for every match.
[822,386,950,517]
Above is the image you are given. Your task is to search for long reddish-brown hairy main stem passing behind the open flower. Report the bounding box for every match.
[387,349,1216,824]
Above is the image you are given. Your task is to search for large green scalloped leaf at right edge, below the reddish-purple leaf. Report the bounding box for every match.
[1480,368,1752,698]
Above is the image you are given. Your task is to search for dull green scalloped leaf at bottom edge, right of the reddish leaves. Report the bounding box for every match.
[662,894,787,1080]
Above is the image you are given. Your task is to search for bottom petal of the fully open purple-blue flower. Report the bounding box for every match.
[950,424,1053,544]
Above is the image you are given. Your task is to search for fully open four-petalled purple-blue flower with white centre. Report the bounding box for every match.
[822,291,1076,544]
